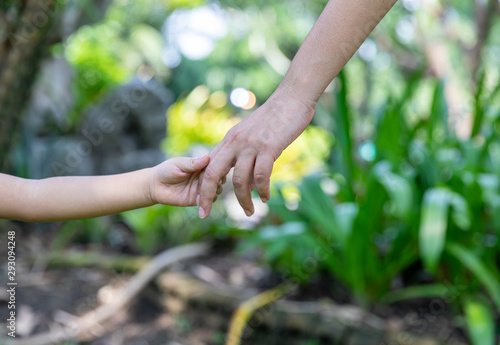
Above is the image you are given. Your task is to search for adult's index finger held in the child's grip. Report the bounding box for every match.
[198,154,233,218]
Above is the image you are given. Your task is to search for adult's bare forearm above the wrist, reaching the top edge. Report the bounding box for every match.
[279,0,397,106]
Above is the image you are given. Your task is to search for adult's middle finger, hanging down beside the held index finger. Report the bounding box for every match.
[233,156,255,217]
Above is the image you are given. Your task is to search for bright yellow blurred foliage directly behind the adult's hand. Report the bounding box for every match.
[163,86,331,181]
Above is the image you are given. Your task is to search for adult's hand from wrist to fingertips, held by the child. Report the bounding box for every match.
[199,89,316,218]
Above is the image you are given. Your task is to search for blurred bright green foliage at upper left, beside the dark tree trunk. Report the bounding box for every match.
[60,0,205,129]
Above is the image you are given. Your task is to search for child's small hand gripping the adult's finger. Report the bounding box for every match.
[150,155,226,206]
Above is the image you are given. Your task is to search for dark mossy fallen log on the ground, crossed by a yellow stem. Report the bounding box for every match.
[156,271,464,345]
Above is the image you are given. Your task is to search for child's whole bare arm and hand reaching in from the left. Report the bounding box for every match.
[0,155,225,222]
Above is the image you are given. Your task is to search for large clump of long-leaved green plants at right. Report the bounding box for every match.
[240,68,500,344]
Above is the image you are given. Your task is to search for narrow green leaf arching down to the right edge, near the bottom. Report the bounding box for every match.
[446,243,500,311]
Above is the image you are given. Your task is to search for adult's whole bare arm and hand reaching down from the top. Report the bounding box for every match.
[199,0,397,218]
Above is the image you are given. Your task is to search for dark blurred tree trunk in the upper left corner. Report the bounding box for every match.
[0,0,62,172]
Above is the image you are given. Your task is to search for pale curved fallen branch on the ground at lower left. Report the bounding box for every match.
[6,243,209,345]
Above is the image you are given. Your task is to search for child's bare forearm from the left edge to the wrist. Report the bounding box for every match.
[0,169,153,222]
